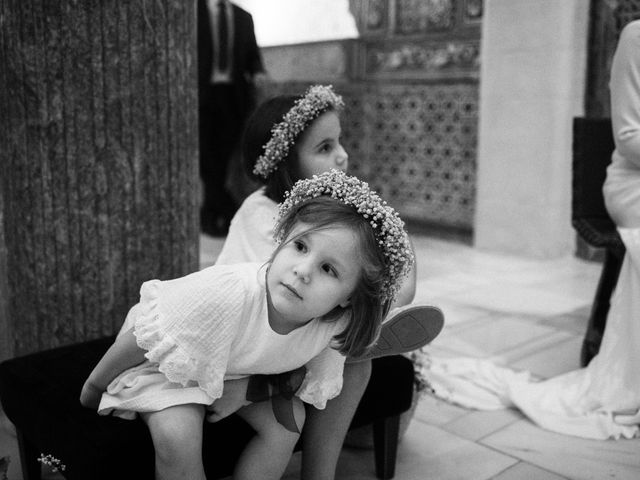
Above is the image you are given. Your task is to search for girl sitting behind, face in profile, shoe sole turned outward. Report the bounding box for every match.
[210,85,443,479]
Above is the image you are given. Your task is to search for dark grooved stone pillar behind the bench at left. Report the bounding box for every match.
[0,0,200,357]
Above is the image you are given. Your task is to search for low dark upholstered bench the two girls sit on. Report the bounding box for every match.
[0,337,414,480]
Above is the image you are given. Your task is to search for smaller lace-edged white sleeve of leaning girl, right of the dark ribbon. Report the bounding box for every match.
[296,347,345,410]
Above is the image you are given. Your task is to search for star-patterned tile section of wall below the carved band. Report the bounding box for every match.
[262,82,478,231]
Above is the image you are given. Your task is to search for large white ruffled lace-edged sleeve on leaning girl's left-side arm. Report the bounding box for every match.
[134,264,256,398]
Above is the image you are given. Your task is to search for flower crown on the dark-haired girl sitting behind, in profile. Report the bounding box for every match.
[253,85,344,178]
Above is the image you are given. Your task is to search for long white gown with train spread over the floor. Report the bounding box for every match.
[426,21,640,439]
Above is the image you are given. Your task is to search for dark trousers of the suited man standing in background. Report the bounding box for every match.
[199,85,244,229]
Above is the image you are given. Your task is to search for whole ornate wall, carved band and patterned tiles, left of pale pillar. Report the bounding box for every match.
[264,0,482,235]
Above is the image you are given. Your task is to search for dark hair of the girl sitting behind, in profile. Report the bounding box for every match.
[242,95,335,203]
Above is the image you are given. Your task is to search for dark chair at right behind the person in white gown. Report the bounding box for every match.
[572,118,625,366]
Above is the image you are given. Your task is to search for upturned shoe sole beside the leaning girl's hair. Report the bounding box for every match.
[357,305,444,361]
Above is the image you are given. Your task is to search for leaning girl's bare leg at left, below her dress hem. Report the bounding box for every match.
[141,404,205,480]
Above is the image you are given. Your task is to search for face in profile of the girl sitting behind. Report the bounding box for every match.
[296,111,349,178]
